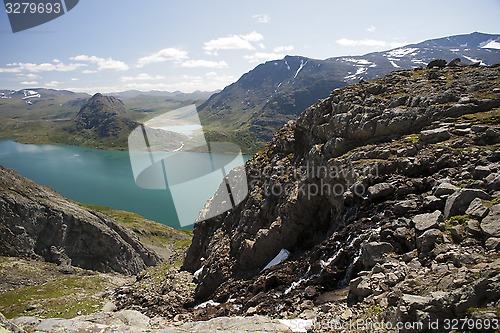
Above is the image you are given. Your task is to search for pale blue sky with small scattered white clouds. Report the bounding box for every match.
[0,0,500,94]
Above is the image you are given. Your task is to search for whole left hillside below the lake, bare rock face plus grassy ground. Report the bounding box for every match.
[0,167,191,320]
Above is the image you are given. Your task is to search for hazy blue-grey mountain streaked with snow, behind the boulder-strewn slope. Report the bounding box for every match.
[199,33,500,151]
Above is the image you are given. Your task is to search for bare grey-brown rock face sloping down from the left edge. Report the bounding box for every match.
[0,167,160,274]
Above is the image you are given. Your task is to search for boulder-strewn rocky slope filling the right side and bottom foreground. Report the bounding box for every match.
[0,61,500,332]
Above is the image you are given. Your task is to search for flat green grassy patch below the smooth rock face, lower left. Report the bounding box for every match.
[0,257,123,318]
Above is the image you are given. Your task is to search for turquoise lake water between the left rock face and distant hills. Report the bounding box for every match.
[0,140,249,229]
